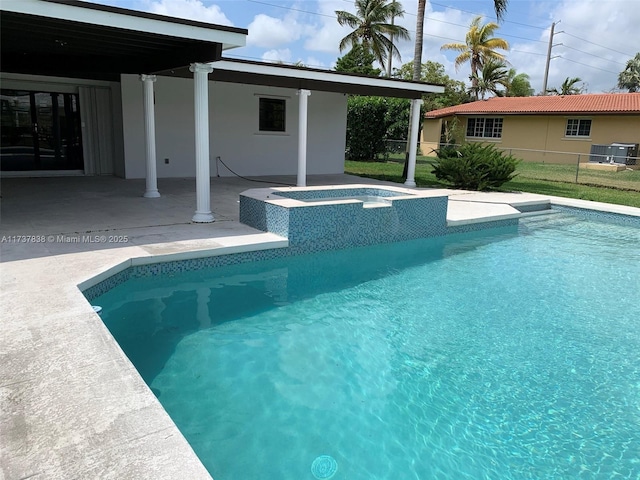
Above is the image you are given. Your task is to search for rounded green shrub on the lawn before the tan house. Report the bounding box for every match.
[433,143,518,190]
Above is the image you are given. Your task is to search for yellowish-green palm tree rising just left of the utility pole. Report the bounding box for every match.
[440,16,509,99]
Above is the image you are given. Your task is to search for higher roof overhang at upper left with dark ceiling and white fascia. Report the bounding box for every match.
[0,0,247,80]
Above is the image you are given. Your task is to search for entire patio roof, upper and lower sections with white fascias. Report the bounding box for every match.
[0,0,444,98]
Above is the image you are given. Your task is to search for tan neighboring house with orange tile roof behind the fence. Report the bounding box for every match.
[422,93,640,163]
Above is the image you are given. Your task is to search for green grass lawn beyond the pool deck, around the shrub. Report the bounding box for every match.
[345,157,640,208]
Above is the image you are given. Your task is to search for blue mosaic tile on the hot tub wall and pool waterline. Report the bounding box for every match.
[83,201,640,302]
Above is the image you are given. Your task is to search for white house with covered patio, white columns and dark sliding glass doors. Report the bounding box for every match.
[0,0,444,221]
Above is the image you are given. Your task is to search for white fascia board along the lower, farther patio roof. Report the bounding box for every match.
[211,60,444,93]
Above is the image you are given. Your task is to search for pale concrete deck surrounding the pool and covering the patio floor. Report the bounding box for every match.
[0,175,640,480]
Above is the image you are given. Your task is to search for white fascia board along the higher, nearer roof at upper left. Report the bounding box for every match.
[2,0,246,50]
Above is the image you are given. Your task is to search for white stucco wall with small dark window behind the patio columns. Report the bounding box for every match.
[122,75,347,178]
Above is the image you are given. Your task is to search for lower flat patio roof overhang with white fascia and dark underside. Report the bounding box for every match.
[161,59,444,98]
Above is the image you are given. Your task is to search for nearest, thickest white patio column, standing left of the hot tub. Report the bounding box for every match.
[189,63,213,223]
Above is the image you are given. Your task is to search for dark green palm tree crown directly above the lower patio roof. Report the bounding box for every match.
[336,0,410,68]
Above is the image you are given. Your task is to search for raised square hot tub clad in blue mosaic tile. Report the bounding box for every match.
[240,185,447,251]
